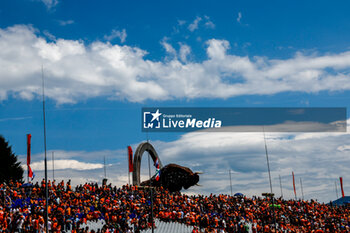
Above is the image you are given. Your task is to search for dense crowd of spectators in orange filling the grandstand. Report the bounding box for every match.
[0,181,350,233]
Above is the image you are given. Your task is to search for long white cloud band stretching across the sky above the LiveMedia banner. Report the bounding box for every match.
[0,25,350,104]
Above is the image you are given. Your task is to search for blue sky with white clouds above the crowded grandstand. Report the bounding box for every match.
[0,0,350,201]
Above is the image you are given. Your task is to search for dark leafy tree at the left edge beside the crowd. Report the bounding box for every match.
[0,135,24,184]
